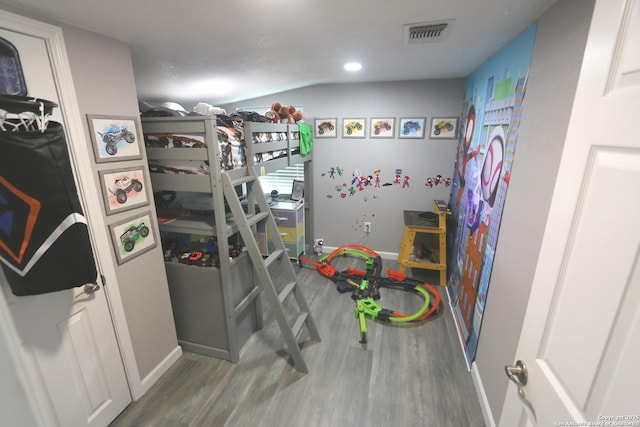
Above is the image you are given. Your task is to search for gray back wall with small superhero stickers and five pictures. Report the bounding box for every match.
[225,79,464,253]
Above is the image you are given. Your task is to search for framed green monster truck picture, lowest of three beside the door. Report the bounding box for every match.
[109,212,158,264]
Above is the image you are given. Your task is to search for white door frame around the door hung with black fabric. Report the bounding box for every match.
[0,5,142,425]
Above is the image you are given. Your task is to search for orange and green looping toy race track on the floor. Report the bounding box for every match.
[300,245,441,346]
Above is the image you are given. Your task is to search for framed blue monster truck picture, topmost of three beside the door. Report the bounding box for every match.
[87,114,142,163]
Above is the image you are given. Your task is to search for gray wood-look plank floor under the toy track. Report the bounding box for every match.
[111,258,484,427]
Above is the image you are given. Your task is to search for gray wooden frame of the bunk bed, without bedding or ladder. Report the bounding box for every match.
[141,116,310,363]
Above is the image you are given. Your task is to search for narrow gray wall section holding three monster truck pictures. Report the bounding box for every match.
[60,25,177,379]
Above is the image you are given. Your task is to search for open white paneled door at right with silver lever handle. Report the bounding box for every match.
[500,0,640,427]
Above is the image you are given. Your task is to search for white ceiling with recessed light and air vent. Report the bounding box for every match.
[0,0,556,105]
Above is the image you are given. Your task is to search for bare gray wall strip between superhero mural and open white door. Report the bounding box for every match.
[476,0,594,421]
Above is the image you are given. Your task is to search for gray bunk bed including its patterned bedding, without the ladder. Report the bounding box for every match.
[142,116,310,363]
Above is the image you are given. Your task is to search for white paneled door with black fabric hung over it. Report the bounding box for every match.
[0,14,131,427]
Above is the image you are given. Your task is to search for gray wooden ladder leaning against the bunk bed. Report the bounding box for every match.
[222,167,320,373]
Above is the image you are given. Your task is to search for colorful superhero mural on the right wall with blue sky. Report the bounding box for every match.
[447,24,536,365]
